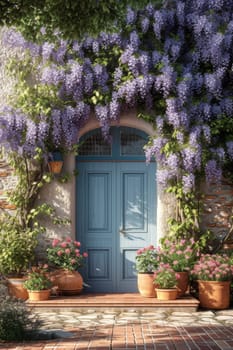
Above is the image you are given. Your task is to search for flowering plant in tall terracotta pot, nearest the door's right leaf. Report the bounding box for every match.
[136,245,158,298]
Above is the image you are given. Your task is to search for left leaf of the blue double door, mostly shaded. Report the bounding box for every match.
[77,162,116,292]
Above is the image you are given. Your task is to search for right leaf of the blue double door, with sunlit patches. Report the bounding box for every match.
[117,162,156,292]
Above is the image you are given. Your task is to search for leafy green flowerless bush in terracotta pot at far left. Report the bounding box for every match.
[0,215,38,300]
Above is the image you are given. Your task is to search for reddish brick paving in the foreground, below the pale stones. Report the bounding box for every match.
[0,322,233,350]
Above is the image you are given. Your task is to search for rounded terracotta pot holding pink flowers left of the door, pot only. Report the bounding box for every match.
[52,270,83,295]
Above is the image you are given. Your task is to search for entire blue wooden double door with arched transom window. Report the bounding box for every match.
[77,128,156,292]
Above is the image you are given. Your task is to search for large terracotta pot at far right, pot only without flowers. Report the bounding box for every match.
[198,280,231,309]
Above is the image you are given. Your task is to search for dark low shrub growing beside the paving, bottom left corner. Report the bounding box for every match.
[0,297,42,341]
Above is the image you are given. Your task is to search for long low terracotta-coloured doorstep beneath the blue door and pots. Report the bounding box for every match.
[26,293,199,312]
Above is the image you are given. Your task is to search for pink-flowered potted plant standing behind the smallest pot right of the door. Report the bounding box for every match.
[158,238,199,296]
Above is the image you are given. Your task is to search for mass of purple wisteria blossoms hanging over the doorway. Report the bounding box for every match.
[0,0,233,193]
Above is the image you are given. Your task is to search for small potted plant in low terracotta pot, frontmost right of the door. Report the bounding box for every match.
[153,263,179,300]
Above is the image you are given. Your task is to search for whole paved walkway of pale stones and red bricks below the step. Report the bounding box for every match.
[0,309,233,350]
